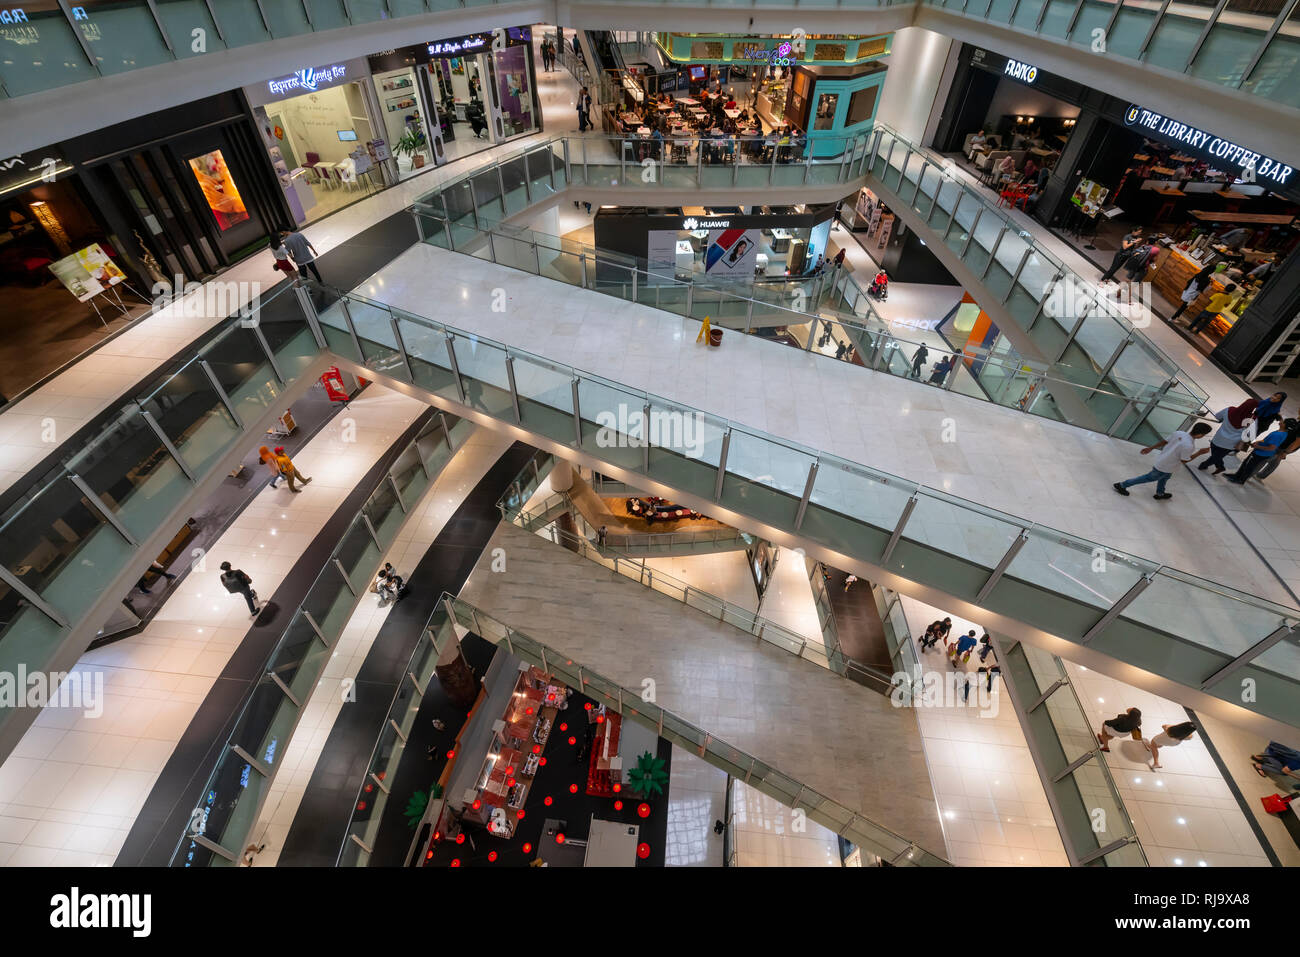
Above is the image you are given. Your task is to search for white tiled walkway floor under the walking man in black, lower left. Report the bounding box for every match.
[0,386,425,866]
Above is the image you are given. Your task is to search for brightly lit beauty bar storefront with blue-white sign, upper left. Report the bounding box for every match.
[244,59,393,225]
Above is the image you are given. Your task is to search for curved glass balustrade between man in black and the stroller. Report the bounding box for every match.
[172,412,460,867]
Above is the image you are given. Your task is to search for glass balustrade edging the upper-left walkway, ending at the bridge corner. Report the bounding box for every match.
[0,285,325,686]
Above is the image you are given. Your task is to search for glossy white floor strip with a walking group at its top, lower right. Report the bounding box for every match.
[902,596,1069,867]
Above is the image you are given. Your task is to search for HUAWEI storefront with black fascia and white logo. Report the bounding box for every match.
[593,205,835,285]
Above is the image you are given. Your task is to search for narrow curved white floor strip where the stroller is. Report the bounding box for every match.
[244,429,511,867]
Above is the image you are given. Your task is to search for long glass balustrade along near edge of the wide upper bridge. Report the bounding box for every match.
[312,287,1300,724]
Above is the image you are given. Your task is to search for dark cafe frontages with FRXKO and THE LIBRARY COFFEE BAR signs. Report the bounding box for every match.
[935,44,1300,355]
